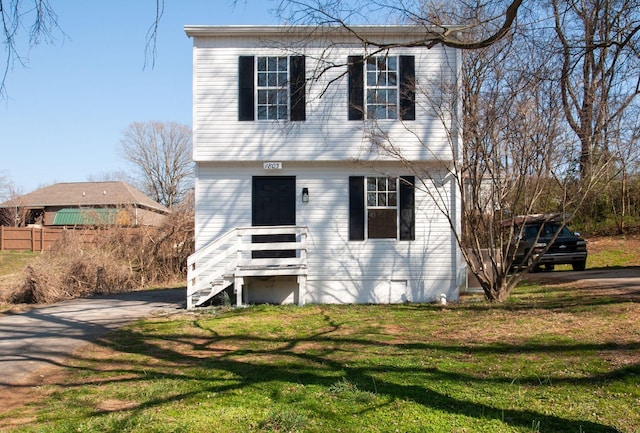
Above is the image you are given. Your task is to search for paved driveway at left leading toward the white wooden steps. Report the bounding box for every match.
[0,289,185,388]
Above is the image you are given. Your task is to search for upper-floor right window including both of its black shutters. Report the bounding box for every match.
[348,56,416,120]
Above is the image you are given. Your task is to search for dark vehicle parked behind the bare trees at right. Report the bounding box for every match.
[510,221,587,271]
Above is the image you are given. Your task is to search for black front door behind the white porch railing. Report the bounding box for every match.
[251,176,296,258]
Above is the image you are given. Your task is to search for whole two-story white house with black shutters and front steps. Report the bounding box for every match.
[185,26,465,308]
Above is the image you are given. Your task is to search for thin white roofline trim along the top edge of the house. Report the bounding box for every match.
[184,24,461,39]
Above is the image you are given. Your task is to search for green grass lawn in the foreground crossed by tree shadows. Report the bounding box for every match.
[0,285,640,433]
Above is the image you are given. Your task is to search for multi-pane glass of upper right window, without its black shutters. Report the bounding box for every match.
[366,56,399,119]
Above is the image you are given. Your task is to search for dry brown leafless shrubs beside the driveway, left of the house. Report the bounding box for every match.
[10,205,193,303]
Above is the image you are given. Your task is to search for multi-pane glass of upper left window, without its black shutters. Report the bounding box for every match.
[256,57,289,120]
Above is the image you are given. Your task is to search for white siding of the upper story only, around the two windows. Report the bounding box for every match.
[194,37,456,161]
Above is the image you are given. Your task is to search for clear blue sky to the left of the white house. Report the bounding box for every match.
[0,0,278,193]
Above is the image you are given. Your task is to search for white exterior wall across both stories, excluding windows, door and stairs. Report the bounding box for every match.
[188,26,463,303]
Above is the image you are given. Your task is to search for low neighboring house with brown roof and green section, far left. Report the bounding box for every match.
[0,182,169,227]
